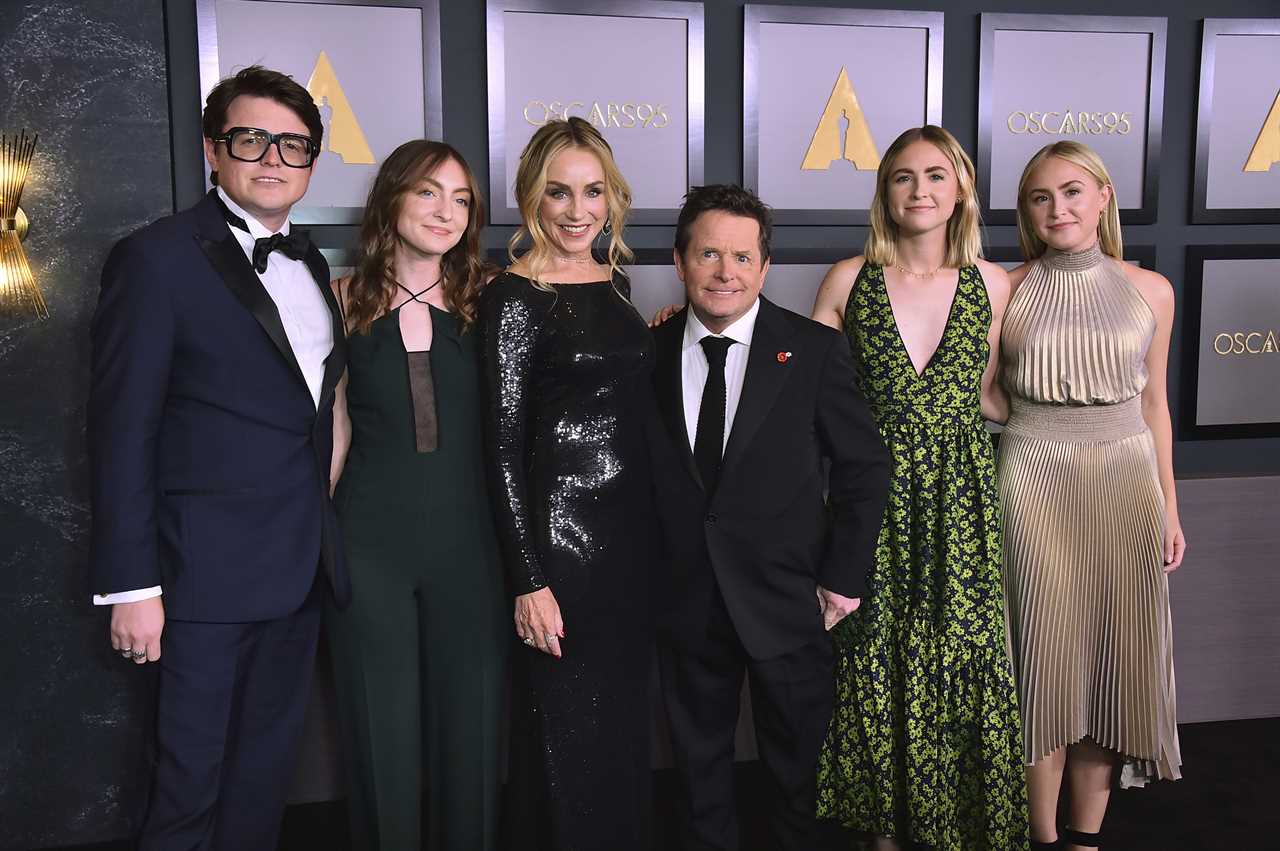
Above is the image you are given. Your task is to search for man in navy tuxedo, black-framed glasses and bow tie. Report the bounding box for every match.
[88,67,349,851]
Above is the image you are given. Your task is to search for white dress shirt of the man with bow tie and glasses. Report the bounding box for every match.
[93,187,335,605]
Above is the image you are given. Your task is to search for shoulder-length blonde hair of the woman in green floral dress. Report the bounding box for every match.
[863,124,982,269]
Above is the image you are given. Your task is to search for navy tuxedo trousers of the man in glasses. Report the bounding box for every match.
[137,581,324,851]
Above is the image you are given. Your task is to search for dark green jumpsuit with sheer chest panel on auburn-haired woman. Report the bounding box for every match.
[326,308,512,851]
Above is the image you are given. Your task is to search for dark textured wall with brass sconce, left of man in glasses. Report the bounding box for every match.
[0,0,173,848]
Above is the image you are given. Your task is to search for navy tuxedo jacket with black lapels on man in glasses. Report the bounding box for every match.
[88,193,349,622]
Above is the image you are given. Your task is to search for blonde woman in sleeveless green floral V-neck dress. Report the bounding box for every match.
[814,125,1028,851]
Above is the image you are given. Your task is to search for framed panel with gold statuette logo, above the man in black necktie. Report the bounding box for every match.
[742,4,943,225]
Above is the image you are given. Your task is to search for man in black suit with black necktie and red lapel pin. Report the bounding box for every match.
[653,186,888,851]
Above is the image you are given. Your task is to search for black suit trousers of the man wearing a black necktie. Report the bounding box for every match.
[658,589,835,851]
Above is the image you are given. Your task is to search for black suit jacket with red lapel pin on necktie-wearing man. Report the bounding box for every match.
[650,298,890,659]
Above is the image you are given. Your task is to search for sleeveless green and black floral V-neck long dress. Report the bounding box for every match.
[818,264,1028,851]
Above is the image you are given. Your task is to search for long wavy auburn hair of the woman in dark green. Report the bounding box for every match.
[346,139,497,334]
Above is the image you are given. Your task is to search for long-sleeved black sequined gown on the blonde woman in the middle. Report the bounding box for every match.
[481,273,655,851]
